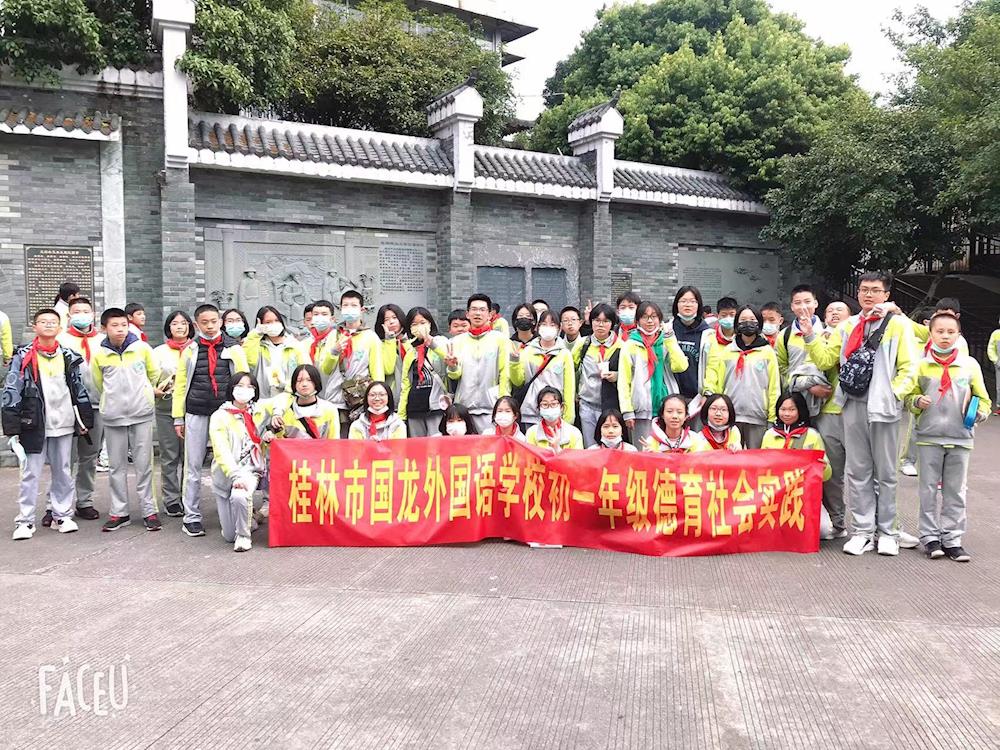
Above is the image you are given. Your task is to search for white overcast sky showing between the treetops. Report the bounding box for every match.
[504,0,959,119]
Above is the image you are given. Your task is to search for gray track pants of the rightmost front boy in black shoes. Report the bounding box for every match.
[917,445,972,547]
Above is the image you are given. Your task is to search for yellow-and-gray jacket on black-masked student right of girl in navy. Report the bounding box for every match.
[705,339,781,424]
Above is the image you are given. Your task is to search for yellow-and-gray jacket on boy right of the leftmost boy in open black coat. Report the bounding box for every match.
[90,331,160,427]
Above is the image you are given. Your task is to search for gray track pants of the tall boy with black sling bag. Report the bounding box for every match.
[841,398,899,539]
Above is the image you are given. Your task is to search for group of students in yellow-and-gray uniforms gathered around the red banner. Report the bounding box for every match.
[2,273,1000,561]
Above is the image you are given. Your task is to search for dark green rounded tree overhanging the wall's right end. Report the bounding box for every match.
[764,102,968,296]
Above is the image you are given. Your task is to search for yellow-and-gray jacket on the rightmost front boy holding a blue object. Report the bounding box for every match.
[906,354,990,448]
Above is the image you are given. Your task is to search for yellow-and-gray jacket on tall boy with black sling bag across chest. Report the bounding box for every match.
[808,315,917,422]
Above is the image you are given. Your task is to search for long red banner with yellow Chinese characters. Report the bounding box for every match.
[268,437,823,556]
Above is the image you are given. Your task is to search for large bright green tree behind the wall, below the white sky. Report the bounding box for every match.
[531,0,863,193]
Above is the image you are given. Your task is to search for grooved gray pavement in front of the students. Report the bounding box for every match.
[0,420,1000,750]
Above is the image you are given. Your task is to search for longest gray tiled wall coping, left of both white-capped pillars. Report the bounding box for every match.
[188,113,454,174]
